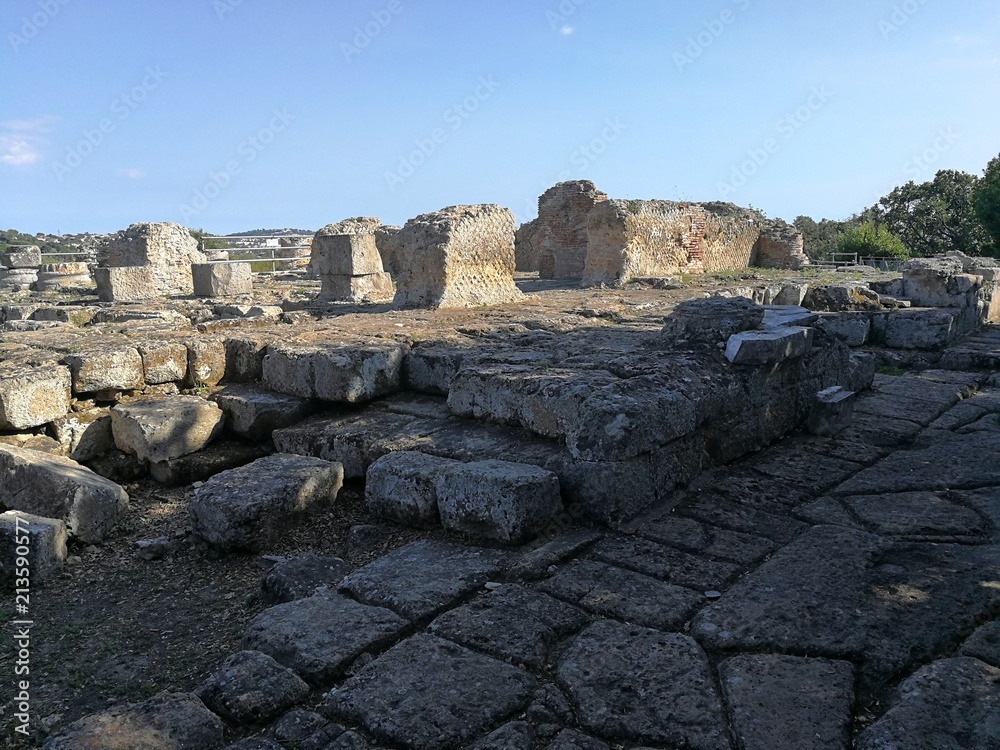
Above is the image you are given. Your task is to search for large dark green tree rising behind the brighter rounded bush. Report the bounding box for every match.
[861,169,991,256]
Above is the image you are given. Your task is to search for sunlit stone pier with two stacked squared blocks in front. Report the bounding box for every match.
[310,217,395,302]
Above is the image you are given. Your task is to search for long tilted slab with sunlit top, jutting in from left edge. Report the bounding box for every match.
[0,445,128,544]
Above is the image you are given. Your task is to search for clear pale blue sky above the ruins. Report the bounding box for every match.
[0,0,1000,233]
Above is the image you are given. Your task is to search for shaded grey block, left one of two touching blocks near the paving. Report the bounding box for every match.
[365,451,459,528]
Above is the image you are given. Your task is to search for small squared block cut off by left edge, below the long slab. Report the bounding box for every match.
[0,510,67,589]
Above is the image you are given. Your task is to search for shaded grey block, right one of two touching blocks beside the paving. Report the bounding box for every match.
[435,461,563,542]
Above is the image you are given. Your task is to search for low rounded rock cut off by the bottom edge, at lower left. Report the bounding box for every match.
[43,693,224,750]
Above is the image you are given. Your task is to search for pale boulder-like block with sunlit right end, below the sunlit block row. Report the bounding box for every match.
[111,396,225,463]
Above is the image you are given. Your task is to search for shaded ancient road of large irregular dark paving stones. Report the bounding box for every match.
[45,356,1000,750]
